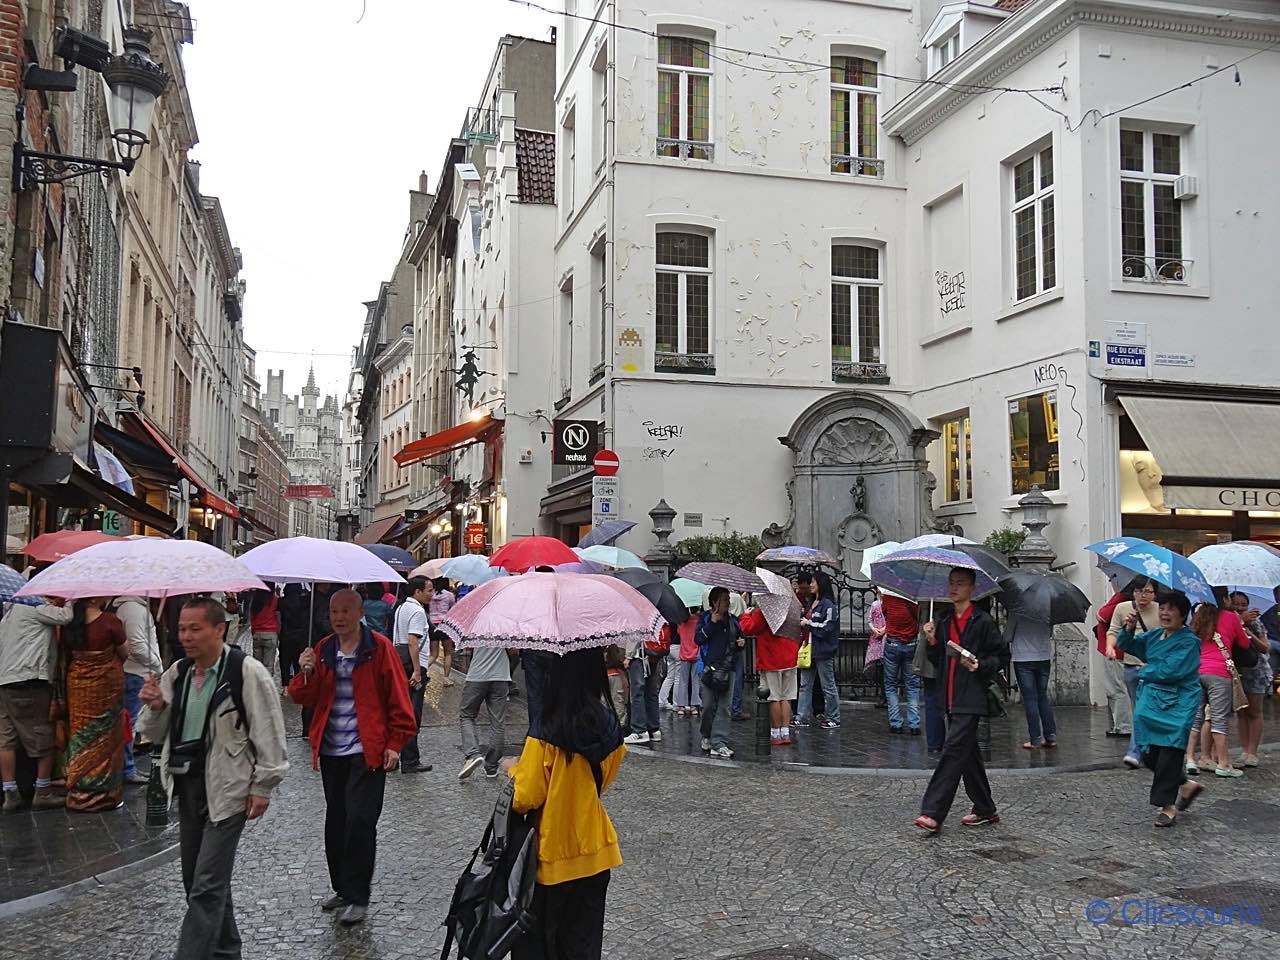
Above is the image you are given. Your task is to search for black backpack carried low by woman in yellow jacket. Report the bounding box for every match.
[440,780,538,960]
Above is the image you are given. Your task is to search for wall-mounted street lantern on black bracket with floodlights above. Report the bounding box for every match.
[13,27,169,191]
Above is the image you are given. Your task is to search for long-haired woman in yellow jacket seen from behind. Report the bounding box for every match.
[509,649,626,960]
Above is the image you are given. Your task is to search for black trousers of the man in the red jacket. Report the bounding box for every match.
[320,753,387,906]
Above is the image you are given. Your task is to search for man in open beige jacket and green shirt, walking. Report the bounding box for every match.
[138,598,289,960]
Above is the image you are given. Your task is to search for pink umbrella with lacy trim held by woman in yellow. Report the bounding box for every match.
[440,573,663,654]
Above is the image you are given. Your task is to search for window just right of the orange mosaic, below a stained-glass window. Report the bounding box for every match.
[654,230,714,370]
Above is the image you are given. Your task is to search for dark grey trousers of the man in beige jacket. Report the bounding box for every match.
[173,771,244,960]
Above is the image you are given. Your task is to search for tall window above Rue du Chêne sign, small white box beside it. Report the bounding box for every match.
[1120,129,1190,283]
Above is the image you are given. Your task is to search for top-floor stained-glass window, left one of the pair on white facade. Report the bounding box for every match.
[658,37,713,160]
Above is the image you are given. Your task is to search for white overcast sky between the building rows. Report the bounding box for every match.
[184,0,557,402]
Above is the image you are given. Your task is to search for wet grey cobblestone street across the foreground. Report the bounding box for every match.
[0,701,1280,960]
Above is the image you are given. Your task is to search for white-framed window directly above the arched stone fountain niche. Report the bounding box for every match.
[831,243,884,378]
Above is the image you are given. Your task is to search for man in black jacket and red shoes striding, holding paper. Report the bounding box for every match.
[915,567,1006,833]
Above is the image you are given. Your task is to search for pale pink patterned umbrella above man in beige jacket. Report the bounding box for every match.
[17,538,264,600]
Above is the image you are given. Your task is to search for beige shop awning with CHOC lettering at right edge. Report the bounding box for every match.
[1120,396,1280,511]
